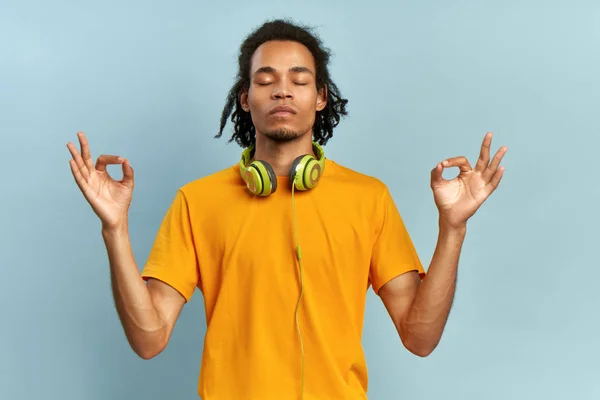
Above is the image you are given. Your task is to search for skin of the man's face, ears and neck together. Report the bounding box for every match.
[240,41,327,176]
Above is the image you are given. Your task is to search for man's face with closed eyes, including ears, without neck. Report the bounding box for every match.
[240,41,327,142]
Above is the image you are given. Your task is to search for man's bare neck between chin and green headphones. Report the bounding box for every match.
[252,134,315,176]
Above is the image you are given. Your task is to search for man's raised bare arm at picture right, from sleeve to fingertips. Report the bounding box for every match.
[378,133,507,357]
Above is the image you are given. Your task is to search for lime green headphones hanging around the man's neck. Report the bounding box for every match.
[240,142,325,196]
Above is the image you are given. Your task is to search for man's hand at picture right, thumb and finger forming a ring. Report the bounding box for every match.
[431,132,507,227]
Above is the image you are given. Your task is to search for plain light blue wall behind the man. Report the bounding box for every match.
[0,0,600,400]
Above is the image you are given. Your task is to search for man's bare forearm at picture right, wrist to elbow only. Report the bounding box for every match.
[401,222,466,355]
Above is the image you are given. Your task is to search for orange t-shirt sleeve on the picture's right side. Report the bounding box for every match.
[369,187,425,294]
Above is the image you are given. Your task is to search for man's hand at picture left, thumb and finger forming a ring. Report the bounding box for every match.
[67,132,133,228]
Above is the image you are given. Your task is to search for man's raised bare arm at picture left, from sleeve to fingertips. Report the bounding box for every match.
[67,133,185,359]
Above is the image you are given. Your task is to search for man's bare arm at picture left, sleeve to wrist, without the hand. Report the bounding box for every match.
[102,224,185,360]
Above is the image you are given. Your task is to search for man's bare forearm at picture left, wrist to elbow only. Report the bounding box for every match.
[102,224,166,358]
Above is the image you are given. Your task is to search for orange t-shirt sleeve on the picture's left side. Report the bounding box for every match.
[142,189,200,301]
